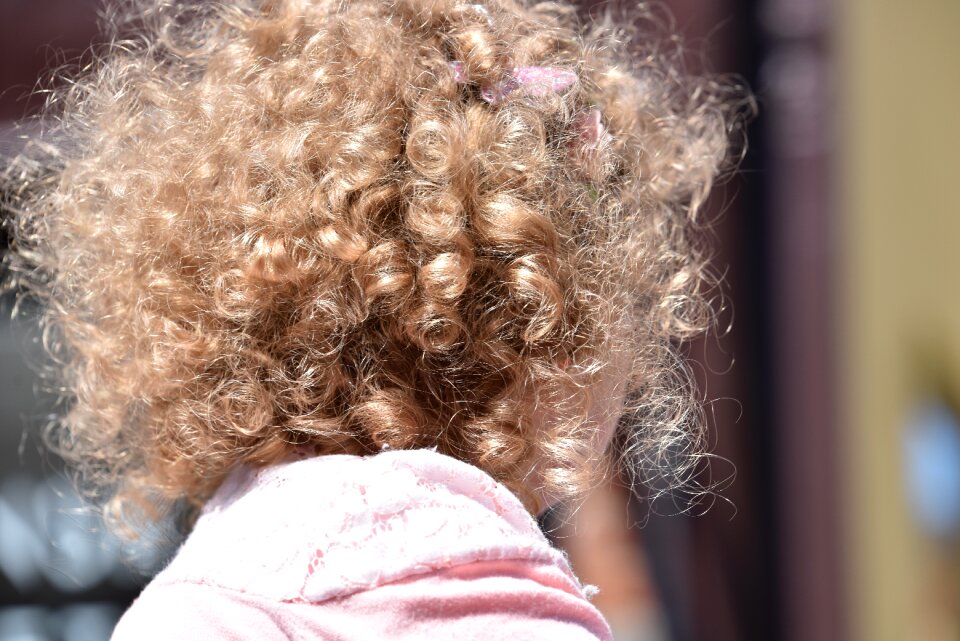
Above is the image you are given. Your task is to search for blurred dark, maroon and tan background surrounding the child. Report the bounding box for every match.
[0,0,960,641]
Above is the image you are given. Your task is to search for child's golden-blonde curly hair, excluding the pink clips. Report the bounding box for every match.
[3,0,739,524]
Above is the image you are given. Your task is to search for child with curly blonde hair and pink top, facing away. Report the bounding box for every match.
[4,0,736,640]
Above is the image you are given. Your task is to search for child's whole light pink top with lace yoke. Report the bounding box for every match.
[112,450,611,641]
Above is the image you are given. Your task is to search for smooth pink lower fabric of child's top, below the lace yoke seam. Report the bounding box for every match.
[111,561,612,641]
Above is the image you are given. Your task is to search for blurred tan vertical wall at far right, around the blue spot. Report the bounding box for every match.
[835,0,960,641]
